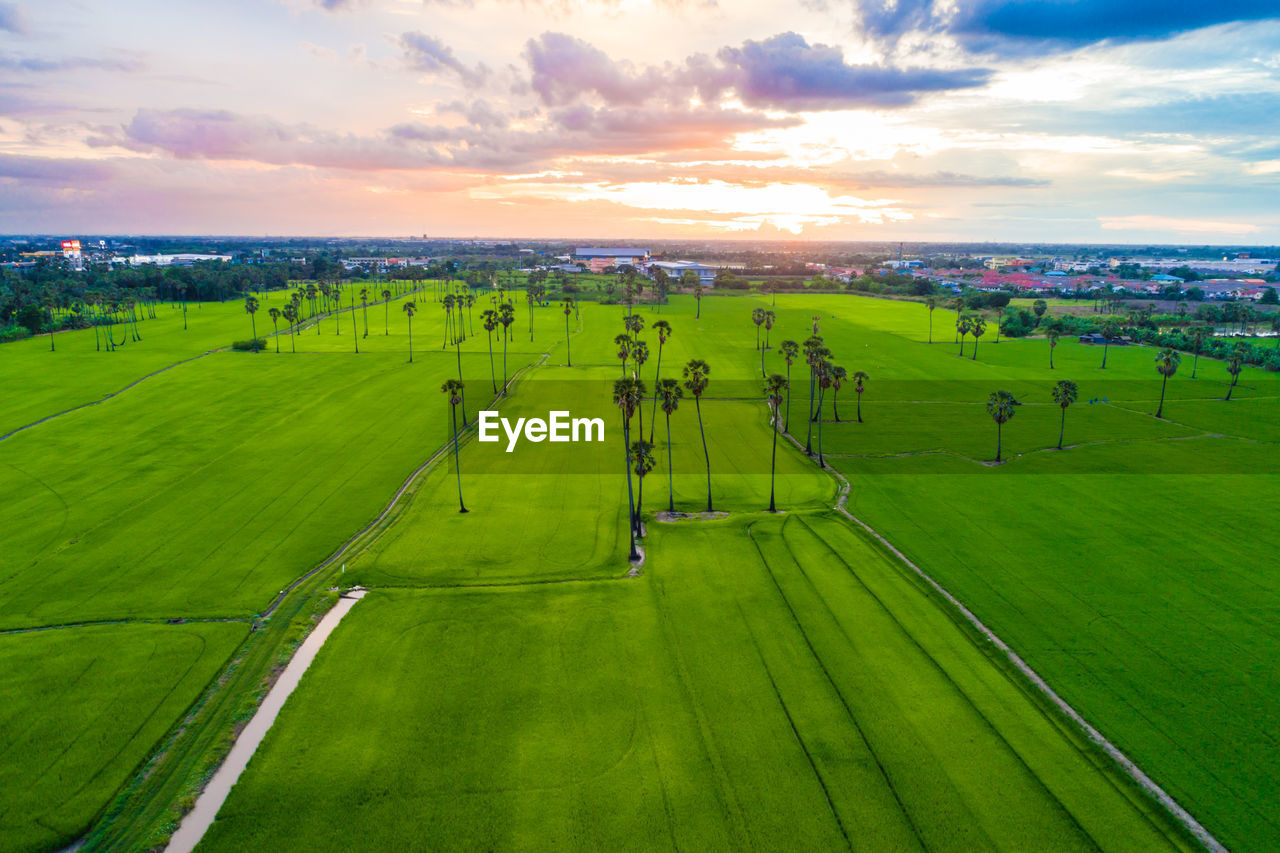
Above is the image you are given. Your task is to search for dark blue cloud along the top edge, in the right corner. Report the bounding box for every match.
[855,0,1280,54]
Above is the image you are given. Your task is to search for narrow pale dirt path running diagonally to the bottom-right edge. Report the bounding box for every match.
[782,420,1229,853]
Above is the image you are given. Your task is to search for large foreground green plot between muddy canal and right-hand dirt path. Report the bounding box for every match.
[201,515,1178,850]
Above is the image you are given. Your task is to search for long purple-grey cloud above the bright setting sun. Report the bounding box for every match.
[525,32,992,111]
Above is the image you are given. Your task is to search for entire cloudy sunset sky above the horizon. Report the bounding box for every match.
[0,0,1280,245]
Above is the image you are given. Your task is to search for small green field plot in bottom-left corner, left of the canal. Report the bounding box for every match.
[0,622,248,850]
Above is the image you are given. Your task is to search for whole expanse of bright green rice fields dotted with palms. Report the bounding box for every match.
[0,291,1280,852]
